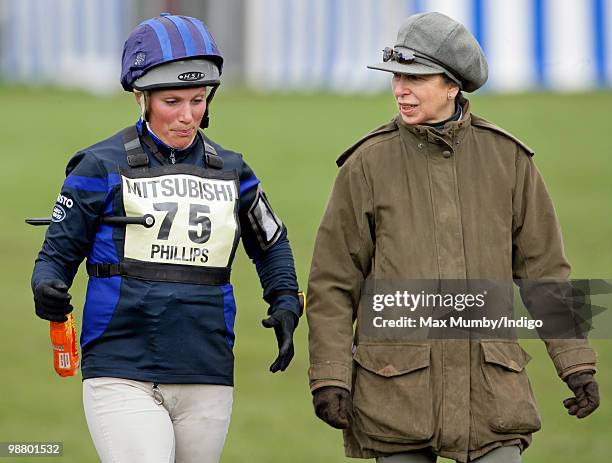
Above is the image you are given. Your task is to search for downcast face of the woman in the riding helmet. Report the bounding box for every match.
[143,87,206,149]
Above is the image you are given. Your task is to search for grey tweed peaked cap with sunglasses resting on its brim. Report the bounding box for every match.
[368,13,488,92]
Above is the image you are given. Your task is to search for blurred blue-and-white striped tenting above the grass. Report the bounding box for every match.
[0,0,612,93]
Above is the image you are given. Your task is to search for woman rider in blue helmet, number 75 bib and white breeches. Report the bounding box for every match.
[32,14,300,463]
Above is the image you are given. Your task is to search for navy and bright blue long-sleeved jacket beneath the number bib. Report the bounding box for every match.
[32,123,299,385]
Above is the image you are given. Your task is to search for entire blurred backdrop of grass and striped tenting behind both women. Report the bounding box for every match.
[0,0,612,463]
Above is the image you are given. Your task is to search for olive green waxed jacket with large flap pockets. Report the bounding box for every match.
[307,100,596,462]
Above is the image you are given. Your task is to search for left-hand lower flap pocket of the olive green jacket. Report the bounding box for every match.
[353,344,434,443]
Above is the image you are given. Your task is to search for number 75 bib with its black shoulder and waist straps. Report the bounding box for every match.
[87,127,240,285]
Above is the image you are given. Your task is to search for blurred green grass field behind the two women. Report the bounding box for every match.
[0,87,612,463]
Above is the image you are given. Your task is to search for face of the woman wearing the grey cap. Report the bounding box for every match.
[391,74,459,125]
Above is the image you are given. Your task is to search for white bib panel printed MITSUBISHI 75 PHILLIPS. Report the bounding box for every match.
[121,166,239,267]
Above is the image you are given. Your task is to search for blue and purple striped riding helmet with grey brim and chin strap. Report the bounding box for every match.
[121,13,223,128]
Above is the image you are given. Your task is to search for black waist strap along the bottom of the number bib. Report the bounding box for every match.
[87,259,231,285]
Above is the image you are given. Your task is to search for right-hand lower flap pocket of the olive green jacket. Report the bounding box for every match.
[481,341,541,433]
